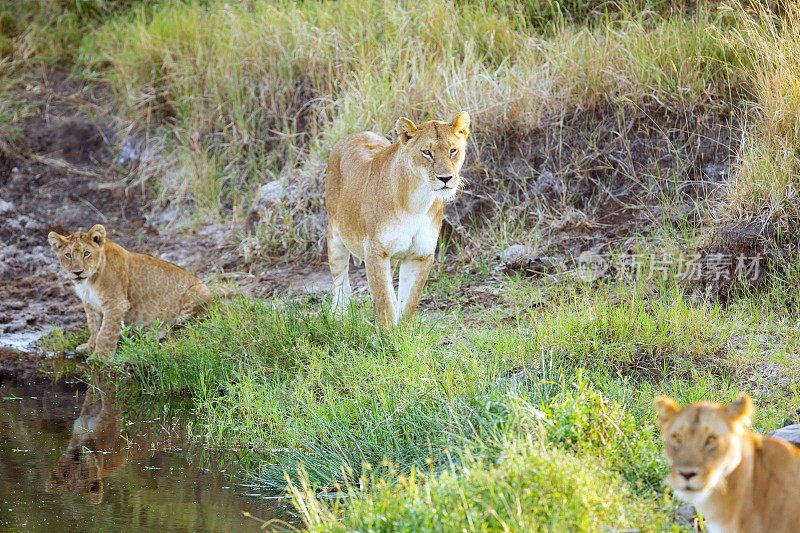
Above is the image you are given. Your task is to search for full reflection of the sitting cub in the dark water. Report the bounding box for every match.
[45,381,178,504]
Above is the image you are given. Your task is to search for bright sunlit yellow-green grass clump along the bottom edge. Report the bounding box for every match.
[292,430,666,531]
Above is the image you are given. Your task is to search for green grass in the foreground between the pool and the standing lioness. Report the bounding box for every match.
[98,256,798,530]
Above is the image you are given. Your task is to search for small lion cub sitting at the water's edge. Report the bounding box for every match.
[47,224,212,357]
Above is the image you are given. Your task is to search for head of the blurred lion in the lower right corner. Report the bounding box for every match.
[655,394,753,503]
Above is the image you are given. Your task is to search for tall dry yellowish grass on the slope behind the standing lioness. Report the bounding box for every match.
[82,0,744,246]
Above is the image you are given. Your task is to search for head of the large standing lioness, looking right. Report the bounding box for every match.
[395,112,469,199]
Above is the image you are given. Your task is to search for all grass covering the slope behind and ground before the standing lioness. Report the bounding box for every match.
[0,0,800,531]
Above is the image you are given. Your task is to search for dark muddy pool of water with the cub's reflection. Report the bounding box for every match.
[0,374,291,532]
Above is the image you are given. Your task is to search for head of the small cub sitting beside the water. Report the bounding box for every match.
[47,224,106,281]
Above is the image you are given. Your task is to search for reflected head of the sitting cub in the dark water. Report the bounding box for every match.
[45,446,103,504]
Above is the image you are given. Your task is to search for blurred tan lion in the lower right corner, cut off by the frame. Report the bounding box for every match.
[655,394,800,533]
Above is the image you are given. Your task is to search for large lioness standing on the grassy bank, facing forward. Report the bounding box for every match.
[325,112,470,329]
